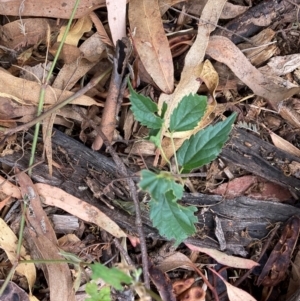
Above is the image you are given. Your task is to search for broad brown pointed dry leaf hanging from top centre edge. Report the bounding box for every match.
[128,0,174,94]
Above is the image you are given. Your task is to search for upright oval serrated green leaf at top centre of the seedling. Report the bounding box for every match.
[169,94,207,133]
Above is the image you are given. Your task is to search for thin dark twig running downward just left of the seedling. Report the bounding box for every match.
[89,120,150,289]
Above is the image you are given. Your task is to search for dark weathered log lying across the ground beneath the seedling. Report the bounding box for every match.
[0,129,300,255]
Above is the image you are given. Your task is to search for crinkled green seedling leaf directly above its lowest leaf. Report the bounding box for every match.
[139,170,183,201]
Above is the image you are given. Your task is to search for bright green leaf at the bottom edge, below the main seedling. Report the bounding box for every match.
[91,263,132,290]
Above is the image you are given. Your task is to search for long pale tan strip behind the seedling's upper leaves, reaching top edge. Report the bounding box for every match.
[158,0,226,165]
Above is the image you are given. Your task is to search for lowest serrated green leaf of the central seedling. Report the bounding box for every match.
[150,190,197,245]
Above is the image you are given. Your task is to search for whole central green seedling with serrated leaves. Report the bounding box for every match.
[129,83,236,245]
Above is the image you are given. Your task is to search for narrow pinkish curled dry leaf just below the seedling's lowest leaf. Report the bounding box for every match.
[185,244,259,269]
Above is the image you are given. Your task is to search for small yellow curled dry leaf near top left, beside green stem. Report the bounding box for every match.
[57,15,93,46]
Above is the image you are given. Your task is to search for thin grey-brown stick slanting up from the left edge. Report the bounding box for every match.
[0,68,112,139]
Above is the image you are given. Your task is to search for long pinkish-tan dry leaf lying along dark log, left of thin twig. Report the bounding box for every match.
[35,183,126,238]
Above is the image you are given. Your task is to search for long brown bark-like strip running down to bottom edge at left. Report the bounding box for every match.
[16,170,75,301]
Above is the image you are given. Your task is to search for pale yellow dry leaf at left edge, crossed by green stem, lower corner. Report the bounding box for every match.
[0,218,36,291]
